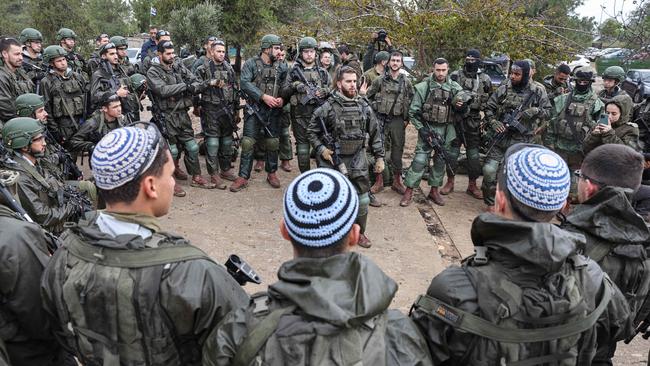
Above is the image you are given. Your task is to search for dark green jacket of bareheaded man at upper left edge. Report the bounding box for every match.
[0,65,34,123]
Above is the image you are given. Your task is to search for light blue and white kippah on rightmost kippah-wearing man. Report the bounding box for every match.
[506,147,571,211]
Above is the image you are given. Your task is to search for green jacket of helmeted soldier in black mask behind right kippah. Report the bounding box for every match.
[545,90,605,153]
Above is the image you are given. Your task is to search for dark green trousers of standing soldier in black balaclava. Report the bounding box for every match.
[447,112,481,180]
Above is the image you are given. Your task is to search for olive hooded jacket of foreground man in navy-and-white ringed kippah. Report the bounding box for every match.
[203,252,432,366]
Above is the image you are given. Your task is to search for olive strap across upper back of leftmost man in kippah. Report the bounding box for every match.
[64,232,214,268]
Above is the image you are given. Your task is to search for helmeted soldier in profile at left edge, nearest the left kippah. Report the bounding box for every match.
[2,117,91,234]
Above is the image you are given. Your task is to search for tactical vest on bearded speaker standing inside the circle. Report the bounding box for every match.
[330,98,369,157]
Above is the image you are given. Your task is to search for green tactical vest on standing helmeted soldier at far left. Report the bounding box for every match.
[50,72,86,119]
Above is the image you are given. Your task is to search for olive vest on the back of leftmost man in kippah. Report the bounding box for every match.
[55,226,211,366]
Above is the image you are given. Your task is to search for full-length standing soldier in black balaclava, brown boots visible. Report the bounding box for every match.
[440,49,492,200]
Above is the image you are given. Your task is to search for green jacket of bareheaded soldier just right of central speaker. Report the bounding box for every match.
[366,73,413,120]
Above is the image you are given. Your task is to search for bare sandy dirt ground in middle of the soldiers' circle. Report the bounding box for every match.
[143,94,650,365]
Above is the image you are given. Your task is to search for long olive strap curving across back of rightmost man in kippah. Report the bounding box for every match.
[414,277,612,343]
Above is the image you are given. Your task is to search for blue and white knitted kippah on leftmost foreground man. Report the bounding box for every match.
[91,127,159,190]
